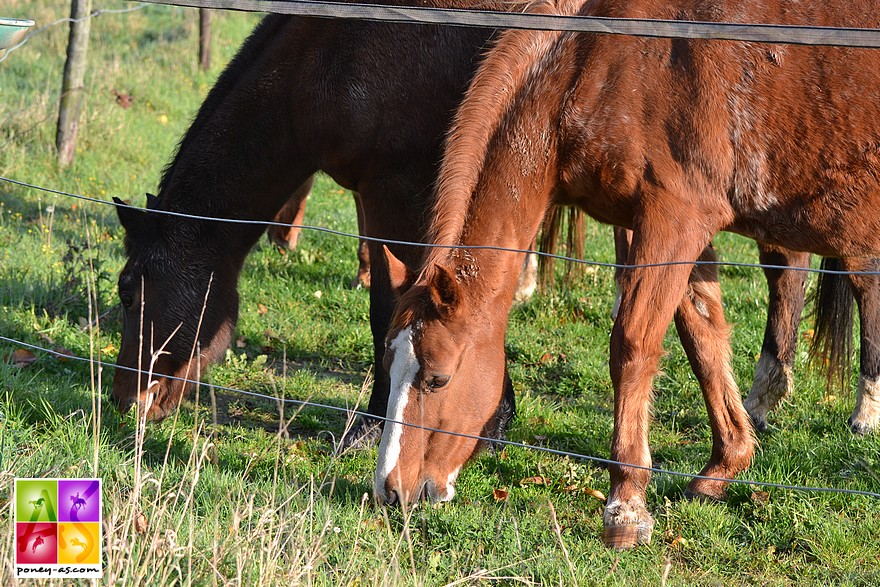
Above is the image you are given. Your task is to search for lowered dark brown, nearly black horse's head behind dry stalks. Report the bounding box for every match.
[111,195,240,420]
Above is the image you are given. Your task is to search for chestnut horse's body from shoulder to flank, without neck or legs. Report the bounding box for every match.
[560,0,880,255]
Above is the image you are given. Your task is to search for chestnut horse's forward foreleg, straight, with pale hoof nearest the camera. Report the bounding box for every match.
[603,223,714,548]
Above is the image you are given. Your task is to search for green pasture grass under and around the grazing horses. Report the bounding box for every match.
[0,0,880,585]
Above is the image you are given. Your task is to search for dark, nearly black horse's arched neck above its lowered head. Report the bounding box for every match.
[158,16,310,234]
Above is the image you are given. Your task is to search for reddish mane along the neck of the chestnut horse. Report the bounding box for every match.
[425,0,582,268]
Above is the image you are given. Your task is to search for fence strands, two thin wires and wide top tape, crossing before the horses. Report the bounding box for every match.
[0,0,880,506]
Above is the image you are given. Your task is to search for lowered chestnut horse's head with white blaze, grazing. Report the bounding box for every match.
[374,249,515,504]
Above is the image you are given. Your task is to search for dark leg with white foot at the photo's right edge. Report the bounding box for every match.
[843,258,880,434]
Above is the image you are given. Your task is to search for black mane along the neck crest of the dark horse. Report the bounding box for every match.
[153,14,291,195]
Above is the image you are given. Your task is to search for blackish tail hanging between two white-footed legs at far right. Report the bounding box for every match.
[810,258,855,389]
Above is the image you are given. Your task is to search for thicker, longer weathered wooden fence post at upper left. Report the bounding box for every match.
[55,0,92,167]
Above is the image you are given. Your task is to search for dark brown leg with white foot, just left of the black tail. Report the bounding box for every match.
[744,243,810,431]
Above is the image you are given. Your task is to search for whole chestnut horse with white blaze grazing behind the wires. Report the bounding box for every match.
[375,0,880,548]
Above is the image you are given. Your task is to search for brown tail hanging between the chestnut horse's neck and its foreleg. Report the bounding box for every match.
[538,204,584,289]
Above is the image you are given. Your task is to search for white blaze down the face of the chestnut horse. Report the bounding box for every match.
[373,326,419,501]
